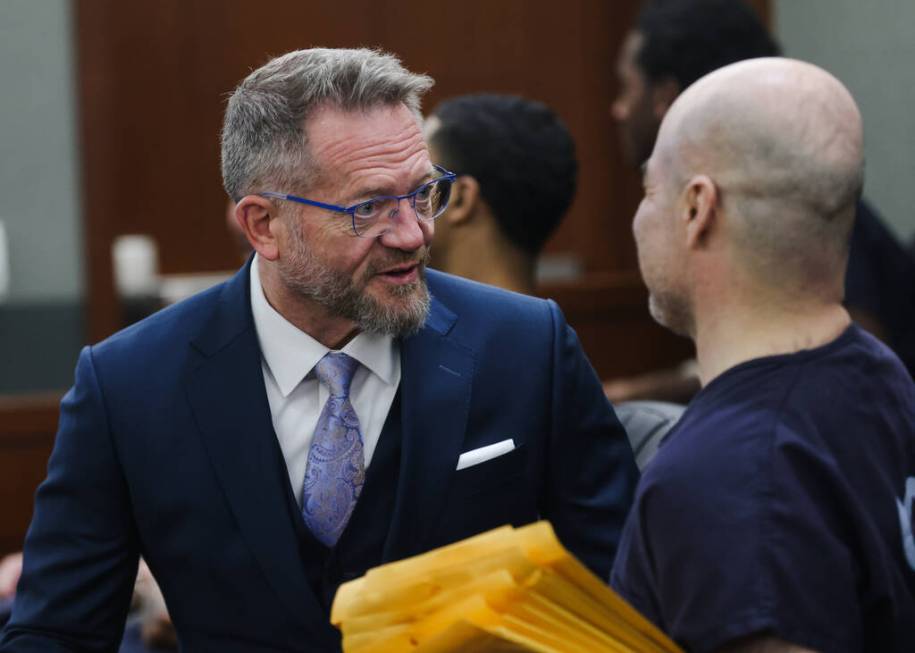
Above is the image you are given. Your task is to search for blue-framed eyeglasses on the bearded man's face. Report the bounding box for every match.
[259,166,456,238]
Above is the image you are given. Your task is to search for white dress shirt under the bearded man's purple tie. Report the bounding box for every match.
[251,256,400,506]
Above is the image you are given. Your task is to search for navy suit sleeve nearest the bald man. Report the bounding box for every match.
[543,301,638,580]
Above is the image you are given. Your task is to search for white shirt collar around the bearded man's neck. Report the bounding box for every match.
[250,254,399,397]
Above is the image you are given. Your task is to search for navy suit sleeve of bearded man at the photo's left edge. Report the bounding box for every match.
[0,347,138,653]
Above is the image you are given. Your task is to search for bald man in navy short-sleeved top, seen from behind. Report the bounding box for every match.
[611,58,915,652]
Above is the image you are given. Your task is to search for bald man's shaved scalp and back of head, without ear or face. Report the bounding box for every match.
[656,58,864,292]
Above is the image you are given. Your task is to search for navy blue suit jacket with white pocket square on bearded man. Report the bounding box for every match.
[0,264,637,653]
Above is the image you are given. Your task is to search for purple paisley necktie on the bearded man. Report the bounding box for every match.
[302,352,365,547]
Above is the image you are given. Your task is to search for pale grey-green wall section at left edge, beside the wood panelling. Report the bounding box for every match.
[0,0,85,304]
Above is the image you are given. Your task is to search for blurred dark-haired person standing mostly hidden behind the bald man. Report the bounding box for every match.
[604,0,915,401]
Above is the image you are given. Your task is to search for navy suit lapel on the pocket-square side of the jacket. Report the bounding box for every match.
[384,292,475,561]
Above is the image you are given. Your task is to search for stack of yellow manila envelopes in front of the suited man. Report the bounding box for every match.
[331,521,680,653]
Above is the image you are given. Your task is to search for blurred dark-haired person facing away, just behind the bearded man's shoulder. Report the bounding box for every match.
[426,94,578,295]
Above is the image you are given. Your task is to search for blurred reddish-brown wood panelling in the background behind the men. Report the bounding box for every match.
[0,0,769,553]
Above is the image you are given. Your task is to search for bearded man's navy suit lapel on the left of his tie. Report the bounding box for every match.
[186,266,323,619]
